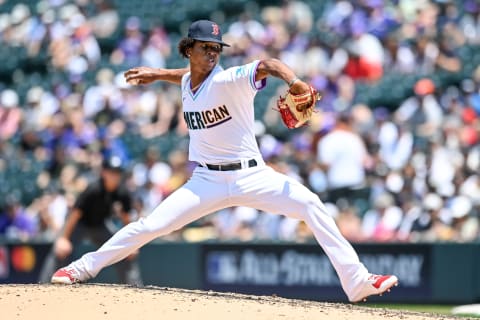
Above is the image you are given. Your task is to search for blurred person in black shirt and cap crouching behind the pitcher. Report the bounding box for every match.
[40,156,141,285]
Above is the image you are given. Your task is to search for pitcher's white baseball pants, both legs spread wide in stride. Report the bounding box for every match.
[71,165,368,297]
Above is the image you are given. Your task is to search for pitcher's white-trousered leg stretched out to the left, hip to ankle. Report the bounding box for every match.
[67,170,231,281]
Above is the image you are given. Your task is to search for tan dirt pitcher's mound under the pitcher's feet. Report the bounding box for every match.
[0,284,462,320]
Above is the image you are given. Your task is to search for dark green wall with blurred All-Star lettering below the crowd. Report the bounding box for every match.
[0,242,480,304]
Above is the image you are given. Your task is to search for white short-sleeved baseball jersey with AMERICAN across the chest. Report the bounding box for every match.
[182,60,266,164]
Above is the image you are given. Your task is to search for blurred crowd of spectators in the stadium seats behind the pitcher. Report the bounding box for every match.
[0,0,480,242]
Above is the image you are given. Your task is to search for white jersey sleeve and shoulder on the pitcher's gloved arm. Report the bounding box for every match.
[214,60,267,94]
